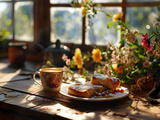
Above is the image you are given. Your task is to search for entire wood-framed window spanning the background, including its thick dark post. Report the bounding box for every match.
[0,0,160,47]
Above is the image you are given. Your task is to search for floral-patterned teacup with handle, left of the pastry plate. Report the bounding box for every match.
[33,68,63,92]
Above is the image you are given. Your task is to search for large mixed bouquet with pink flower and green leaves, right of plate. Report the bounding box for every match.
[105,22,160,91]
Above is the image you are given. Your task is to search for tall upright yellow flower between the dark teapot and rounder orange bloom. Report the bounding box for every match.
[73,48,83,69]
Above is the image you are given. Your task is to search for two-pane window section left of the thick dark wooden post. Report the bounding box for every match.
[0,0,34,41]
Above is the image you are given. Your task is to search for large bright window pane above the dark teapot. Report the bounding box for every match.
[51,8,82,44]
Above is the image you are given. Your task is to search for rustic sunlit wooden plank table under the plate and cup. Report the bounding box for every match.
[0,59,160,120]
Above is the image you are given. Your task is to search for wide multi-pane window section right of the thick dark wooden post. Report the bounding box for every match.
[50,0,160,46]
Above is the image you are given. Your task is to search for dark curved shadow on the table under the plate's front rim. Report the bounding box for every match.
[58,97,132,112]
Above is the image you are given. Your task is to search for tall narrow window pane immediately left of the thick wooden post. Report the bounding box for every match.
[15,2,33,41]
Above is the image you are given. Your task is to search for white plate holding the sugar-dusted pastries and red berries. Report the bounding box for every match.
[60,84,129,101]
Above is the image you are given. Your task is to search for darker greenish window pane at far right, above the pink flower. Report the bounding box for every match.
[126,7,159,41]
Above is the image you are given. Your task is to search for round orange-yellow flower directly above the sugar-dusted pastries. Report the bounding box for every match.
[92,48,102,62]
